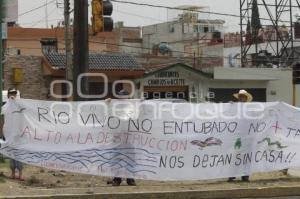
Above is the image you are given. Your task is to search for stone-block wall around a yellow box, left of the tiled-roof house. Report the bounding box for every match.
[3,56,49,100]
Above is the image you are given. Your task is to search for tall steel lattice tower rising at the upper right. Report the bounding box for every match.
[240,0,300,67]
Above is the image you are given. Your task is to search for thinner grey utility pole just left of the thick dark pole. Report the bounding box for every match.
[63,0,72,97]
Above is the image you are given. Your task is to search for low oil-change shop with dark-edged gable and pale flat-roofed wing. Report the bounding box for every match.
[136,63,293,104]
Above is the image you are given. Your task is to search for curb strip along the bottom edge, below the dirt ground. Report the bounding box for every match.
[0,186,300,199]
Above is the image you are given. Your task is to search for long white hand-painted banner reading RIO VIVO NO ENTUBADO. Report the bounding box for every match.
[0,99,300,180]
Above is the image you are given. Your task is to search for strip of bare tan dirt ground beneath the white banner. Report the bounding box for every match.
[0,160,300,196]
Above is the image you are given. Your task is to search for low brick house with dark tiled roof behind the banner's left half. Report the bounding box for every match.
[4,53,144,100]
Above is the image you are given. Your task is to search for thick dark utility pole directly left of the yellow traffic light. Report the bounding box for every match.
[73,0,89,101]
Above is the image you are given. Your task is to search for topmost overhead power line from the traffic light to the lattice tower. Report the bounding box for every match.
[111,0,289,22]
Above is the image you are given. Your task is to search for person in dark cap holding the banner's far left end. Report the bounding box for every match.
[1,88,24,181]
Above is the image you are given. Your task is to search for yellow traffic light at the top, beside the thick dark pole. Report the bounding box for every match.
[92,0,114,35]
